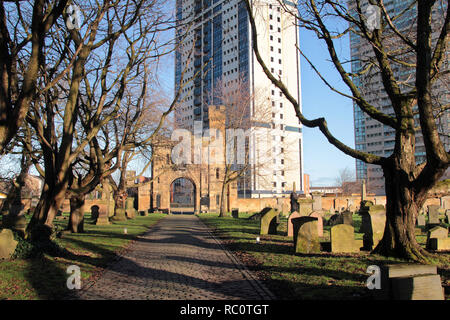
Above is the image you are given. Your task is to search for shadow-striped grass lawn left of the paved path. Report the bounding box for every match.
[0,214,166,300]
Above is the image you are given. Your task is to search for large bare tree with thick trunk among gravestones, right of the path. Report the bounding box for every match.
[245,0,450,261]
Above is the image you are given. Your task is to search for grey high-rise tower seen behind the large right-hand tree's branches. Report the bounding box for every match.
[348,0,450,195]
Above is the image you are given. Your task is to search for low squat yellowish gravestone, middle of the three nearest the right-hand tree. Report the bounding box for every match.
[330,224,363,253]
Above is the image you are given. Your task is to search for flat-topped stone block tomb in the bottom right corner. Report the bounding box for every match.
[376,263,444,300]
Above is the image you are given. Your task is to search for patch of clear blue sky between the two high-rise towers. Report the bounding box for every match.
[300,26,355,186]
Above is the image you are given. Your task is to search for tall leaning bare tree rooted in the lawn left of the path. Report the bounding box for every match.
[23,0,176,238]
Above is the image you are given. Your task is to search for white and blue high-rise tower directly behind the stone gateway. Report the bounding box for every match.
[175,0,304,198]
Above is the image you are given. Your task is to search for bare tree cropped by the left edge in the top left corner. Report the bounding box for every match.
[0,0,67,153]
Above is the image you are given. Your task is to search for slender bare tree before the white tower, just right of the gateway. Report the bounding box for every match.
[213,75,278,217]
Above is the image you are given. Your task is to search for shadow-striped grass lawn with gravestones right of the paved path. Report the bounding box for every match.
[200,213,450,300]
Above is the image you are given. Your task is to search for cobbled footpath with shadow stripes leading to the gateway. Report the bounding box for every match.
[74,215,274,300]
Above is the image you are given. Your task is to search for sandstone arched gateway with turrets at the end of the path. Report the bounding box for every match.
[139,106,237,213]
